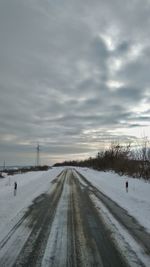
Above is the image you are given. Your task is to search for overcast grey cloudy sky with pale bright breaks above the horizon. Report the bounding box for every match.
[0,0,150,165]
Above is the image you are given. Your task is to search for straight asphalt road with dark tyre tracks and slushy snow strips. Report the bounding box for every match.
[0,169,150,267]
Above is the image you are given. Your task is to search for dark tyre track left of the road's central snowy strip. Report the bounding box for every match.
[13,171,66,267]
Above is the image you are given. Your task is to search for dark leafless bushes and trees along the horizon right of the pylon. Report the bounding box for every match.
[54,142,150,180]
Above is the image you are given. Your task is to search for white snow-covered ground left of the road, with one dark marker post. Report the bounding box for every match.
[0,168,61,240]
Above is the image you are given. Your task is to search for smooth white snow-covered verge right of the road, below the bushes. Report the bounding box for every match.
[78,168,150,232]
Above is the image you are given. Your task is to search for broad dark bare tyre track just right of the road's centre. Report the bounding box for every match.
[74,172,129,267]
